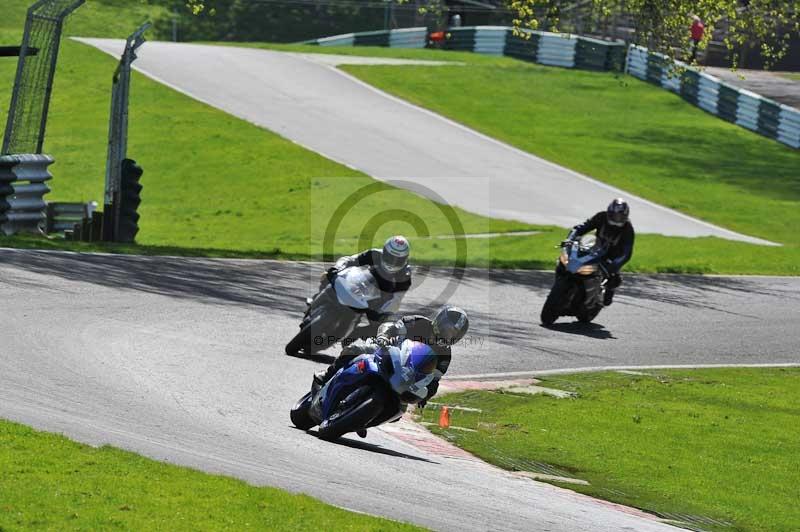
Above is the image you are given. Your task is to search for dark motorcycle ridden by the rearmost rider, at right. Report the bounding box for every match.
[541,235,608,326]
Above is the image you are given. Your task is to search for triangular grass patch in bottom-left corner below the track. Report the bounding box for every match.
[0,420,418,531]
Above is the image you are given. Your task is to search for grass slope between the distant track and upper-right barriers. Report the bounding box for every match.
[343,51,800,244]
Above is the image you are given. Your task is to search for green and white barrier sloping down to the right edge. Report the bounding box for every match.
[625,45,800,148]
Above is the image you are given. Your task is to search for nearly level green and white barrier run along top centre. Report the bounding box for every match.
[303,26,626,70]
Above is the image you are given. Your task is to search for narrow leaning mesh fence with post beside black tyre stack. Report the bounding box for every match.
[103,22,150,242]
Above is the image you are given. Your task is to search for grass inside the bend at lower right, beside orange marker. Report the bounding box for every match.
[424,368,800,531]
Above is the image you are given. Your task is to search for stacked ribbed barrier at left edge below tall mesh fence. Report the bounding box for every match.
[0,155,53,235]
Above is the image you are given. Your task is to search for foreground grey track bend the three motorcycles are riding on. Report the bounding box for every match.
[0,250,800,531]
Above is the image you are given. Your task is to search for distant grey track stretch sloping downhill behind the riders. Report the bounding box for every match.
[79,39,766,244]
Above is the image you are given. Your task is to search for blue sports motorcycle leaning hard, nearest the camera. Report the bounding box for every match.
[290,340,437,441]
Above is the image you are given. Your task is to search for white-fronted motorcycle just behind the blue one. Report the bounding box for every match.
[286,266,405,357]
